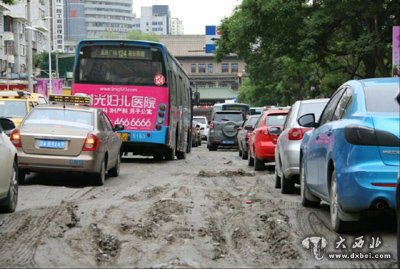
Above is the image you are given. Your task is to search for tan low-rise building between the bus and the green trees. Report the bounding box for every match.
[160,35,245,105]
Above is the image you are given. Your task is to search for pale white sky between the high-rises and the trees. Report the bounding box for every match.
[132,0,242,35]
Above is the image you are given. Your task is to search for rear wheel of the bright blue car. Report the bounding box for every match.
[329,170,349,233]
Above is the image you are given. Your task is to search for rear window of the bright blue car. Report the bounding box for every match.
[364,85,400,113]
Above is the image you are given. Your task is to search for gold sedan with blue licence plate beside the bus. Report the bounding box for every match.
[10,99,124,185]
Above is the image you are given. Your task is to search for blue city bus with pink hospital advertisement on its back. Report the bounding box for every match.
[72,40,192,160]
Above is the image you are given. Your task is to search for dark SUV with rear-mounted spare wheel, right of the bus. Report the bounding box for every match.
[207,110,246,151]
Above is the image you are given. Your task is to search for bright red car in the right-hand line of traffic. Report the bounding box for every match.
[248,110,289,170]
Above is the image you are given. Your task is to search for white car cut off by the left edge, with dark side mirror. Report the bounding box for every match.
[0,118,18,213]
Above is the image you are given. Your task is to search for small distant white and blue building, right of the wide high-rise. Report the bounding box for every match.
[133,5,171,35]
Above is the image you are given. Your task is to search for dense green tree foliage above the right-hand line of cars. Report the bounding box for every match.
[216,0,400,105]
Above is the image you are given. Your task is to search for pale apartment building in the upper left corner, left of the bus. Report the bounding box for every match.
[0,0,49,86]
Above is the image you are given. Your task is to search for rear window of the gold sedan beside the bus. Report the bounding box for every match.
[24,108,94,130]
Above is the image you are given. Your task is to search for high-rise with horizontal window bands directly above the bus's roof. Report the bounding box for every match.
[64,0,134,40]
